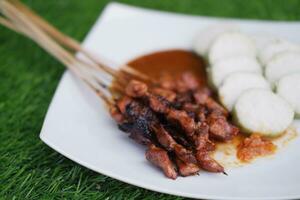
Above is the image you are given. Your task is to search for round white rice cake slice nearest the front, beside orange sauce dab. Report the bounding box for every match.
[234,89,294,137]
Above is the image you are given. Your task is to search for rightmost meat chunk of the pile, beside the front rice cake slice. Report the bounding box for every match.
[207,111,239,141]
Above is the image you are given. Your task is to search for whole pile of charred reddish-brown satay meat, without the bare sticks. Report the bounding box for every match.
[111,69,239,179]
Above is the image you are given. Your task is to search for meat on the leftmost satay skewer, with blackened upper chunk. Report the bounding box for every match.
[111,96,178,179]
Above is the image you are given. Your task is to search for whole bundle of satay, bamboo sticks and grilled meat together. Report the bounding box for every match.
[0,0,239,179]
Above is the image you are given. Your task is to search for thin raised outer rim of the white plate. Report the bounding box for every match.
[39,2,300,200]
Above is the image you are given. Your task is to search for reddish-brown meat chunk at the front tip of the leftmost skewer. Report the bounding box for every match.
[146,144,177,179]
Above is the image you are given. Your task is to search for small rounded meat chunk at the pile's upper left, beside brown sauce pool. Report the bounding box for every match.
[125,80,148,98]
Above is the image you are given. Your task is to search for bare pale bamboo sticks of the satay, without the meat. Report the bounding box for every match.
[0,0,155,104]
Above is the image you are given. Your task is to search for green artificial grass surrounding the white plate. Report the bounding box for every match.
[0,0,300,199]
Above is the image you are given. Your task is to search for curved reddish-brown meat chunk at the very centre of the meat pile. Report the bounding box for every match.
[167,109,196,137]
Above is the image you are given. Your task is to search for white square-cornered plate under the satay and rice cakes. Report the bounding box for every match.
[40,3,300,199]
